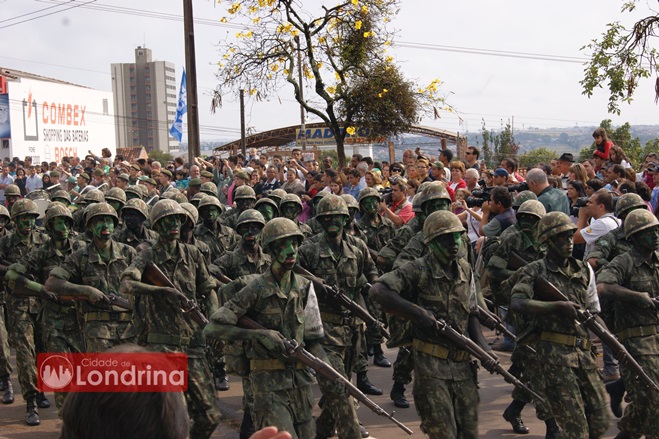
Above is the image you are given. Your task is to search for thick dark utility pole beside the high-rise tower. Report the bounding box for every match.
[183,0,201,166]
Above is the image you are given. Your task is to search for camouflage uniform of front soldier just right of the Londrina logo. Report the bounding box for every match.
[213,271,324,439]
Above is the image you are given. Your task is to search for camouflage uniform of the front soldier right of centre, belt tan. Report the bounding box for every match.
[377,249,479,438]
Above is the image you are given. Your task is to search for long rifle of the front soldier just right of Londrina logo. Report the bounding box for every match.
[237,316,413,434]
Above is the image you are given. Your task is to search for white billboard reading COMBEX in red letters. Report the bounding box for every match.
[0,78,116,164]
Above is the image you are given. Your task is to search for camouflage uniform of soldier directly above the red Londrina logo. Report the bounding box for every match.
[50,241,137,352]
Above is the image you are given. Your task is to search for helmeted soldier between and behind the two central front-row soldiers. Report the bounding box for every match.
[300,195,378,439]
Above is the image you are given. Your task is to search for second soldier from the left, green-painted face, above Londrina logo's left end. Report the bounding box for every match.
[7,202,85,410]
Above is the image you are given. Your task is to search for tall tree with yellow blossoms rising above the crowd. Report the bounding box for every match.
[212,0,453,167]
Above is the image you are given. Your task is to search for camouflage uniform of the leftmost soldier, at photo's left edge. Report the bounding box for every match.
[0,229,50,401]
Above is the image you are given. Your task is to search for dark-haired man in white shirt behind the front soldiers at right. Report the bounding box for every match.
[574,189,620,255]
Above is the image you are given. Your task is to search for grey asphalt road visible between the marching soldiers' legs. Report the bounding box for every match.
[0,332,618,439]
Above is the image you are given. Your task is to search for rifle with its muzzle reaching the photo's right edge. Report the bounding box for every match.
[509,251,659,392]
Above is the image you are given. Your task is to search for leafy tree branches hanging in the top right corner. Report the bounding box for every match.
[580,0,659,115]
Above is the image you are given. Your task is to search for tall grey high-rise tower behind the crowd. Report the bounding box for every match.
[111,46,179,154]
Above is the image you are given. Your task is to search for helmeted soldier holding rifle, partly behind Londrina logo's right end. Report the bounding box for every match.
[119,199,220,439]
